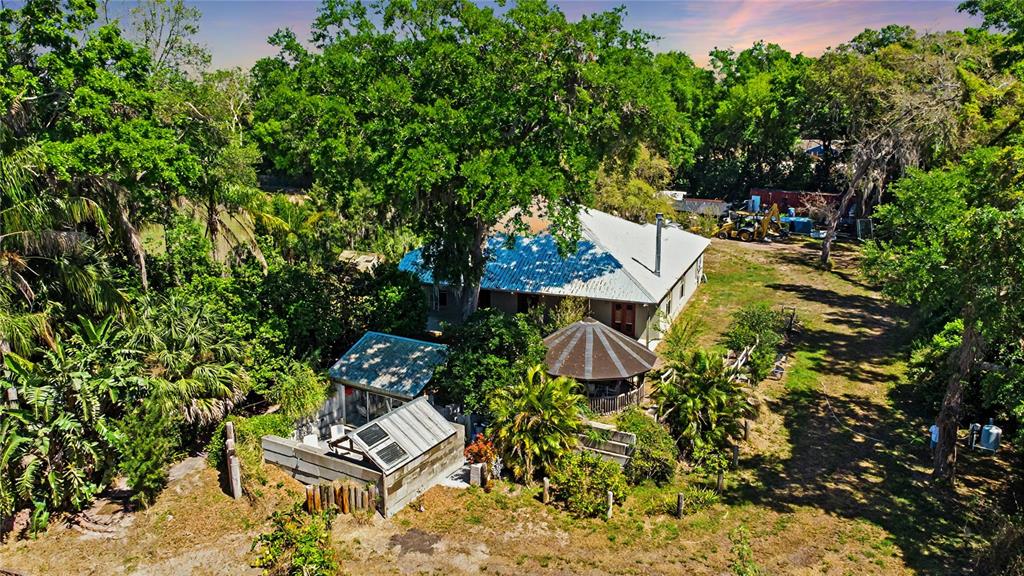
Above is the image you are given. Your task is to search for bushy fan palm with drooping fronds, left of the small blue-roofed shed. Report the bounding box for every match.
[135,295,250,424]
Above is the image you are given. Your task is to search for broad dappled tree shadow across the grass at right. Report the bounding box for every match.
[725,284,1011,574]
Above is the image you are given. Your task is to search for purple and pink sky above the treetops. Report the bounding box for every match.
[174,0,977,68]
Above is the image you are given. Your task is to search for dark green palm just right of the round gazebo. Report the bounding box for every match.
[653,351,753,454]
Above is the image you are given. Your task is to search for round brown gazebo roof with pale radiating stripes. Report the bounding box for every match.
[544,318,657,380]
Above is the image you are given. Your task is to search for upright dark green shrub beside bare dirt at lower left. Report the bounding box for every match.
[118,402,178,507]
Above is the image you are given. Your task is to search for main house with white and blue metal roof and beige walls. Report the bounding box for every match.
[398,209,711,343]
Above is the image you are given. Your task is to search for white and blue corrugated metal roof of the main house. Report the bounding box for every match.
[398,210,710,303]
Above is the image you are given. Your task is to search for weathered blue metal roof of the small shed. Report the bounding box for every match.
[329,332,447,398]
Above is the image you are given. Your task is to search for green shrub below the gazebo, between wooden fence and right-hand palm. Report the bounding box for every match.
[615,406,679,485]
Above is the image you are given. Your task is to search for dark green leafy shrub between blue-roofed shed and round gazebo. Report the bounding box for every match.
[433,310,545,413]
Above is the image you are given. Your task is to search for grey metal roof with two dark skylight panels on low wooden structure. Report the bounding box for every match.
[347,398,455,474]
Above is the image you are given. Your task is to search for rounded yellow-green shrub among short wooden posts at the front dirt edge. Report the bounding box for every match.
[551,452,626,518]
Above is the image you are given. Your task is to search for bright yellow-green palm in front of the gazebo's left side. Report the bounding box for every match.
[489,365,584,483]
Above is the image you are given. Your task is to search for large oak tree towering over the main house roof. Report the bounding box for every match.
[255,0,680,315]
